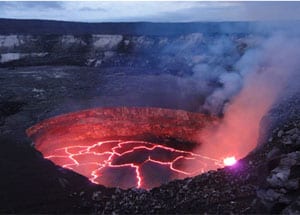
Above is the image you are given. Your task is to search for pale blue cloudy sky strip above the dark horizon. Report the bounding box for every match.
[0,1,300,22]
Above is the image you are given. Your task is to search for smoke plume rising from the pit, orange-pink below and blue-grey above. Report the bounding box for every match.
[197,33,300,159]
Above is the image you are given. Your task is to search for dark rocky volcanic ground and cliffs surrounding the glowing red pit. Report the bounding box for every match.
[0,20,300,214]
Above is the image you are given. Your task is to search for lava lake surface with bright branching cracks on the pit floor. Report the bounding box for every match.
[45,140,218,188]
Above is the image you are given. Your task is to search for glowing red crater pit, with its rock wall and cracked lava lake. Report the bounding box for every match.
[27,107,227,189]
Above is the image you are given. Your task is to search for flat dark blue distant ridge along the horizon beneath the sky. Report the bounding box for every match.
[0,18,250,36]
